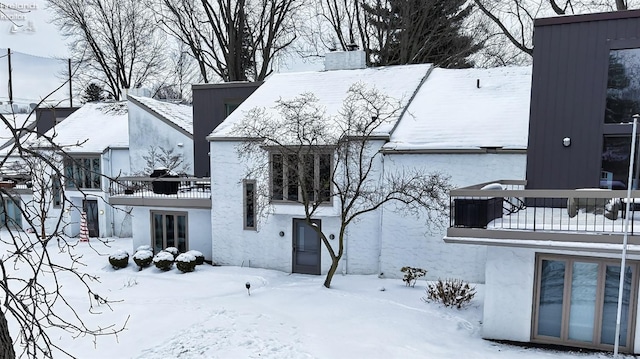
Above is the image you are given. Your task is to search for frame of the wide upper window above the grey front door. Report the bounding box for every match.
[268,148,335,206]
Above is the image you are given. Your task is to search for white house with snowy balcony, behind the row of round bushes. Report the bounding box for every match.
[110,83,259,260]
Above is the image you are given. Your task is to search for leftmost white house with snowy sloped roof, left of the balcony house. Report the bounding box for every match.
[31,102,131,237]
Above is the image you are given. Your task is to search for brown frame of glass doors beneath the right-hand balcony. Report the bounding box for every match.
[531,253,640,352]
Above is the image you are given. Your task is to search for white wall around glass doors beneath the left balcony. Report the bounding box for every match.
[131,206,211,260]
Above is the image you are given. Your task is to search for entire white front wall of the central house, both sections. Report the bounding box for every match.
[210,141,526,283]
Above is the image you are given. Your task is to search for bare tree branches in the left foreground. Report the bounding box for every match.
[0,104,126,359]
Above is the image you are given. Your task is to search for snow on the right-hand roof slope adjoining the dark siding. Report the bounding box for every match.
[384,67,531,150]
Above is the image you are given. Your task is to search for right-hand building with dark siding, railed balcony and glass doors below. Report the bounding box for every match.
[445,10,640,353]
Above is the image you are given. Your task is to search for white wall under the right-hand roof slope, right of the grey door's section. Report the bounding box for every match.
[381,154,526,283]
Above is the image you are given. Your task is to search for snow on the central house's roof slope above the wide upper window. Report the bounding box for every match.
[210,64,431,137]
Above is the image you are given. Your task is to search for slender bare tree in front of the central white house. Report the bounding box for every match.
[234,83,450,288]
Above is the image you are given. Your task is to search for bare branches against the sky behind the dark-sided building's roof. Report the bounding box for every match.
[473,0,638,65]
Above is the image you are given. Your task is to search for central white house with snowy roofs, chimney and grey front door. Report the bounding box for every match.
[208,51,531,281]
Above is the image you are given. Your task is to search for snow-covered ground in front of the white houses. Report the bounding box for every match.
[14,239,636,359]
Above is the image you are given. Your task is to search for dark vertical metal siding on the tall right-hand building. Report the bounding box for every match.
[527,11,640,189]
